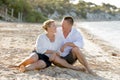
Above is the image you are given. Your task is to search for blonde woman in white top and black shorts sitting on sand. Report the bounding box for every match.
[9,20,60,72]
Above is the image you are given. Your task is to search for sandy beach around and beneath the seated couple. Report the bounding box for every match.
[0,22,120,80]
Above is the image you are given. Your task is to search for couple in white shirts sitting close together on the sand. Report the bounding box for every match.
[10,16,93,74]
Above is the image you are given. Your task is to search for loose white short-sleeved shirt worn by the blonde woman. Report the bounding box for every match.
[35,34,61,57]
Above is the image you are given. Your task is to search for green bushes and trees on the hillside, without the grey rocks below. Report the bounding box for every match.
[0,0,120,22]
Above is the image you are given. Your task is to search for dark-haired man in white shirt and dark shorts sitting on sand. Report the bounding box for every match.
[52,16,94,74]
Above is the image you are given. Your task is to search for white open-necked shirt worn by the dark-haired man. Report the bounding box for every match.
[57,27,83,57]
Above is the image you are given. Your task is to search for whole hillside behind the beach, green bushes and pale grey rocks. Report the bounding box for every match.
[0,0,120,22]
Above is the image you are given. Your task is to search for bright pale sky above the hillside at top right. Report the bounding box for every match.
[71,0,120,8]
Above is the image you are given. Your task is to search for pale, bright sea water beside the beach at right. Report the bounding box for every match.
[77,21,120,49]
